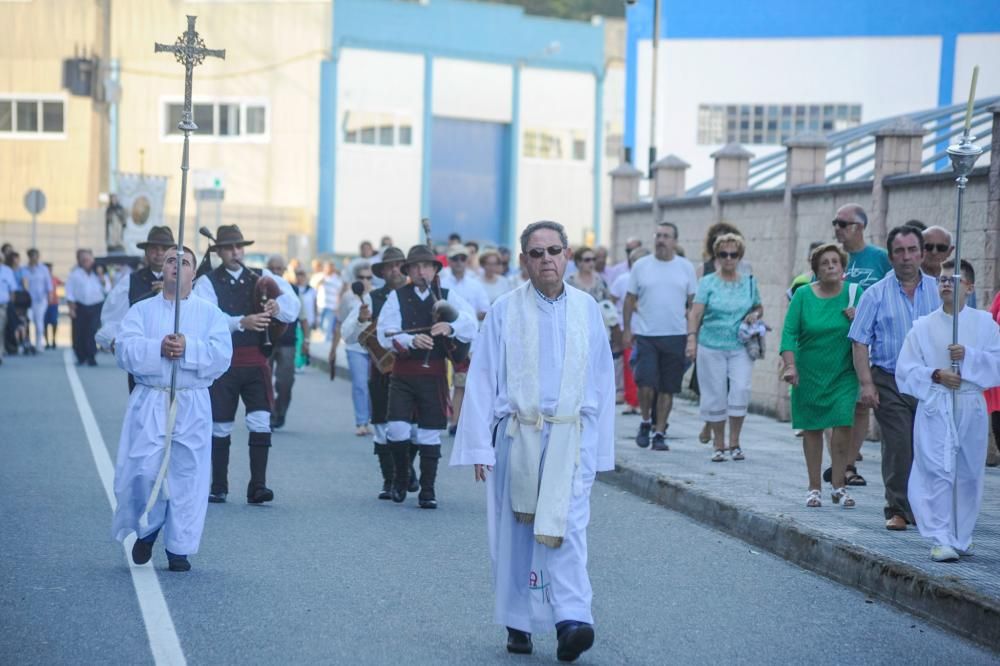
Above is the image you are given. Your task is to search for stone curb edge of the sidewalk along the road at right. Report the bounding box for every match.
[597,464,1000,652]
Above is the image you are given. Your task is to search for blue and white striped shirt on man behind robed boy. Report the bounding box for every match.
[847,272,941,374]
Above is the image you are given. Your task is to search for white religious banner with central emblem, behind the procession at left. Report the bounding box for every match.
[114,173,167,255]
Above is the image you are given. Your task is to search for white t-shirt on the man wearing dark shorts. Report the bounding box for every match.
[628,255,698,336]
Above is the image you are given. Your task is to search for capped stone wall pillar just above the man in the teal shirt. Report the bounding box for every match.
[868,117,927,247]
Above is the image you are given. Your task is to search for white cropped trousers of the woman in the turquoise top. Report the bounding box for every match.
[698,345,753,423]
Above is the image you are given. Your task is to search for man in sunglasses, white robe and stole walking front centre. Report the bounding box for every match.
[451,222,615,661]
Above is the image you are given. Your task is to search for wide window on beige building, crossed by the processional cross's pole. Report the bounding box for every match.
[163,100,268,141]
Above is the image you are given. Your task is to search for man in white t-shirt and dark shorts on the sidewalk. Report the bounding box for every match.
[622,222,698,451]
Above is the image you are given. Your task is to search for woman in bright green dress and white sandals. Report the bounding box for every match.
[781,243,861,509]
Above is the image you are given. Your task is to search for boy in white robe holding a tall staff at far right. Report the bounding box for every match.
[896,261,1000,562]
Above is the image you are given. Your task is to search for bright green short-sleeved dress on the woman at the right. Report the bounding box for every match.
[781,282,861,430]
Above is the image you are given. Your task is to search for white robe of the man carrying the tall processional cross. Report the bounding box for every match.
[111,294,233,555]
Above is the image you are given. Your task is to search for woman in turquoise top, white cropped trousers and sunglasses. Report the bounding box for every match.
[686,234,764,462]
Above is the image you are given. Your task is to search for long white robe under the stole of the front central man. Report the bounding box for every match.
[451,284,615,632]
